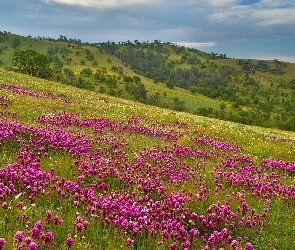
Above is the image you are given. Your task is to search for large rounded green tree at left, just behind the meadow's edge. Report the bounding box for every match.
[12,50,52,79]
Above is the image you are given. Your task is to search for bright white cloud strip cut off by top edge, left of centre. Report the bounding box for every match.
[42,0,162,8]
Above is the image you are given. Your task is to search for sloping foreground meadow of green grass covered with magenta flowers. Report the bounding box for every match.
[0,71,295,250]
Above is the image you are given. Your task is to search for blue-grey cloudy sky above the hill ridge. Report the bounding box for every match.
[0,0,295,63]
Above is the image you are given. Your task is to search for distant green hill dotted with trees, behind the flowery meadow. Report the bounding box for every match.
[0,32,295,130]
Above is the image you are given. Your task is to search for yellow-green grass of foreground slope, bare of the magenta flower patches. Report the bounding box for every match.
[0,70,295,249]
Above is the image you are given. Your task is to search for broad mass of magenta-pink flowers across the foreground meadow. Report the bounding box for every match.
[0,105,295,250]
